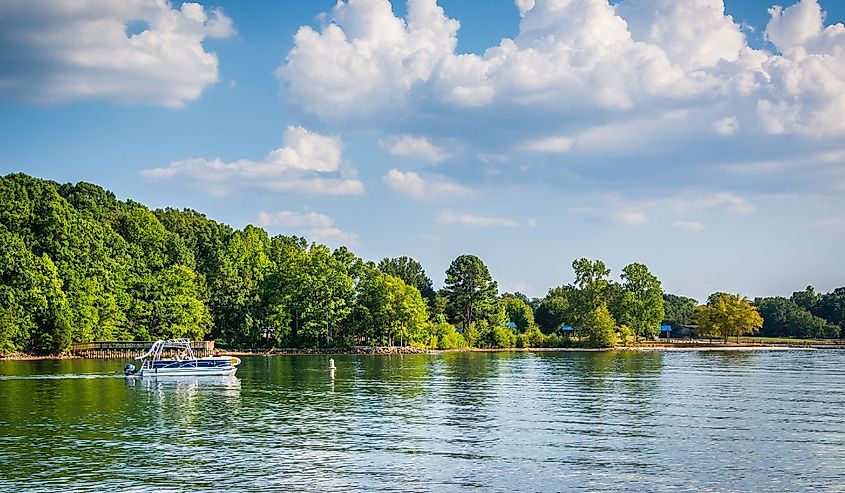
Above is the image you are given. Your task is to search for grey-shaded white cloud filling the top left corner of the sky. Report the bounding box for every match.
[0,0,235,107]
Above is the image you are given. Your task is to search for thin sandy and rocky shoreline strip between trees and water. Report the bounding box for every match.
[0,343,845,361]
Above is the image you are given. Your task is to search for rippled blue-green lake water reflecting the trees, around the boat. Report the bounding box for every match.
[0,350,845,492]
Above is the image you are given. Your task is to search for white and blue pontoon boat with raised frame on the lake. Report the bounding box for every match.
[123,339,241,377]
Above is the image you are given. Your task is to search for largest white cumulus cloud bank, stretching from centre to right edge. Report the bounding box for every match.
[277,0,845,144]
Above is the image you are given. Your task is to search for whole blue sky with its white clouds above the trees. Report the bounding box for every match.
[0,0,845,300]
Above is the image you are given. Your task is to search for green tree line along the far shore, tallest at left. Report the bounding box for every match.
[0,173,845,353]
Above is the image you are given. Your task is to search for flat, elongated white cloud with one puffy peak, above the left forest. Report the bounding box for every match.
[141,126,364,195]
